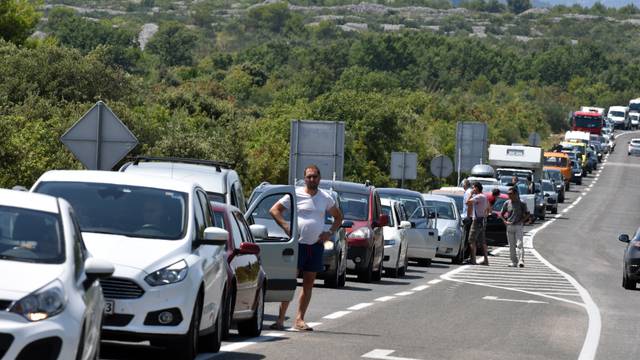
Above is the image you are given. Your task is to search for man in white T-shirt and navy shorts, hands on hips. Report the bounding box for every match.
[269,165,342,331]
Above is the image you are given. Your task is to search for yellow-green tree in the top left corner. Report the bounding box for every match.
[0,0,41,44]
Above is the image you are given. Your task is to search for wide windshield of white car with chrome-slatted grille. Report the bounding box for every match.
[36,181,188,240]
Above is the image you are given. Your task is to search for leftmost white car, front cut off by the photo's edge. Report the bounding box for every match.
[0,189,113,359]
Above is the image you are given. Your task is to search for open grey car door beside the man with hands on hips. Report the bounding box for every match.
[245,185,298,302]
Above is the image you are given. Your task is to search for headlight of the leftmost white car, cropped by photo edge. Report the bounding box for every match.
[9,280,66,321]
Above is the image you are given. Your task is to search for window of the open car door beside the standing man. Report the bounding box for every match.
[249,193,296,242]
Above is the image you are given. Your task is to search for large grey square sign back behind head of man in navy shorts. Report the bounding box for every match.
[289,120,344,185]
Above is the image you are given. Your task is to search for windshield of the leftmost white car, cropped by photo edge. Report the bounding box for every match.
[0,206,65,264]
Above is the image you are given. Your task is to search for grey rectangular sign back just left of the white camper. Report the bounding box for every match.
[455,122,487,172]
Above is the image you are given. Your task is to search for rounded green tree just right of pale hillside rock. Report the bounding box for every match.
[146,22,198,66]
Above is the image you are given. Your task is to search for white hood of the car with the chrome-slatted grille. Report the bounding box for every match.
[82,232,187,272]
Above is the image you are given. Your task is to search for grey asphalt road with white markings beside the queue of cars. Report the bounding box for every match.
[102,135,640,360]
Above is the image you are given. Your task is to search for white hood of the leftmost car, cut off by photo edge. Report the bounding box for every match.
[0,260,64,300]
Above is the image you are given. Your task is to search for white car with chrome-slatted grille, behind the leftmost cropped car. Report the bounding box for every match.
[32,170,228,360]
